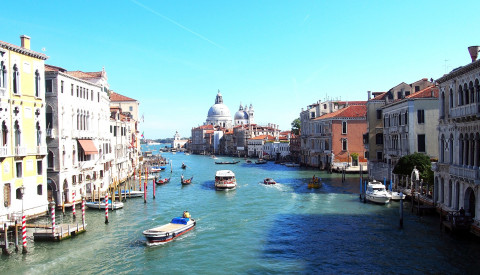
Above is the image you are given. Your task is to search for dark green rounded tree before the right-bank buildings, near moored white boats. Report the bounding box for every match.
[393,153,433,184]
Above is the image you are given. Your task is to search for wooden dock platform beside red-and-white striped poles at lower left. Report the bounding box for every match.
[33,223,87,242]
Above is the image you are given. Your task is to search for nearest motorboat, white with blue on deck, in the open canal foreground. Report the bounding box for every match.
[143,215,197,245]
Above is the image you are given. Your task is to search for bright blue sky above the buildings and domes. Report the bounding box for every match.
[0,0,480,138]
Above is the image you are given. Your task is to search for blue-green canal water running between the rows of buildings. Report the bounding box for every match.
[0,148,480,274]
